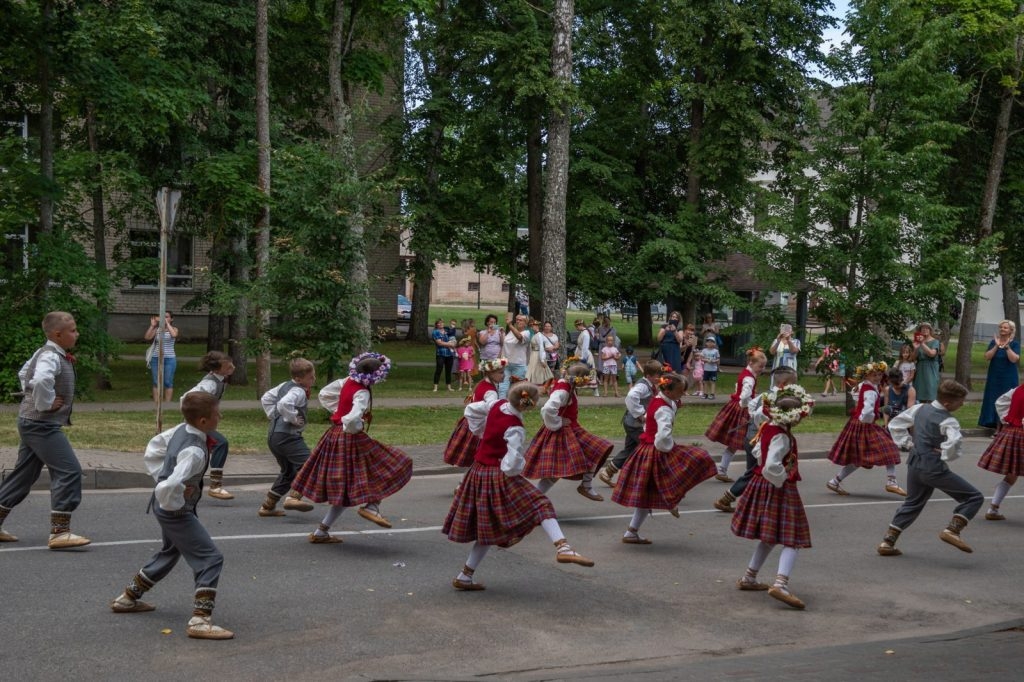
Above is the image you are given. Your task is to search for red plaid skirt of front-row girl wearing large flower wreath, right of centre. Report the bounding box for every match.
[732,474,811,548]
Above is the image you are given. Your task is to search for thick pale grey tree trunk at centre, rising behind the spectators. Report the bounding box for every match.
[541,0,573,339]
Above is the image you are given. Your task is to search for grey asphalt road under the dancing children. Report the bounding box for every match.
[0,452,1024,681]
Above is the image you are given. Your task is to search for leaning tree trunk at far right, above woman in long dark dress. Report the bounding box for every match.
[956,9,1024,388]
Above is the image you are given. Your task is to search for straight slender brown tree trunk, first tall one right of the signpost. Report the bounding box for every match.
[253,0,270,398]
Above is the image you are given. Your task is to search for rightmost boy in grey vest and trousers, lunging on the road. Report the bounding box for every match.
[878,379,985,556]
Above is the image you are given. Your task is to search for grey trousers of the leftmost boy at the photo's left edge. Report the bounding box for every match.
[0,419,82,512]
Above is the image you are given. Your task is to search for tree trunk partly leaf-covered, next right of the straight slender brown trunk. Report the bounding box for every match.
[328,0,371,352]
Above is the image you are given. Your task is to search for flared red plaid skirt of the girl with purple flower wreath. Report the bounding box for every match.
[292,426,413,507]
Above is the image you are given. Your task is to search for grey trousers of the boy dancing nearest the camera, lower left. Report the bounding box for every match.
[142,503,224,589]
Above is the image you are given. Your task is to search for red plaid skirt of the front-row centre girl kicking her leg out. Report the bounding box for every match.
[441,462,555,547]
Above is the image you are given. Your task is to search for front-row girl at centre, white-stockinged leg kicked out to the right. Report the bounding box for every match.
[442,382,594,591]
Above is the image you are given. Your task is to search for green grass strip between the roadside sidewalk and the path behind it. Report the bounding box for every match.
[0,398,980,454]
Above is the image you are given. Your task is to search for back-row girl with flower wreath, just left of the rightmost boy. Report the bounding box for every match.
[825,363,906,498]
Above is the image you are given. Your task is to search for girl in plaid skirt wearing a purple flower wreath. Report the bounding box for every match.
[292,352,413,544]
